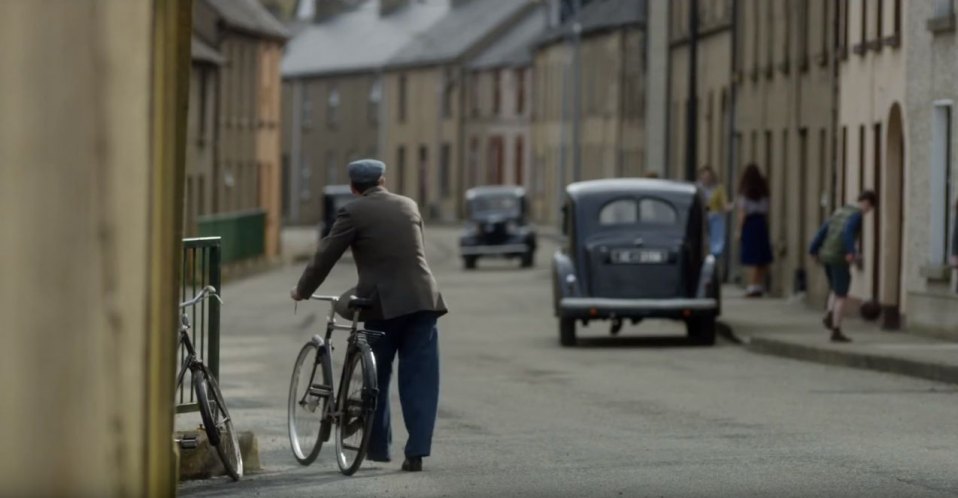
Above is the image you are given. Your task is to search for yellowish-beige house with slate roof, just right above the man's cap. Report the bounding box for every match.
[381,0,536,220]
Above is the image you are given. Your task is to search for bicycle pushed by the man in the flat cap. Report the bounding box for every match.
[289,295,384,476]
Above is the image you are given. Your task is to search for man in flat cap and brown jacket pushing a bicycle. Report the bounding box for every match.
[291,159,446,471]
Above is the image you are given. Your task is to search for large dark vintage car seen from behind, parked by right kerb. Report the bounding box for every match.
[553,179,721,346]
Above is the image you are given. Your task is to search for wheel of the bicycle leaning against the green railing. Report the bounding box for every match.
[193,366,243,481]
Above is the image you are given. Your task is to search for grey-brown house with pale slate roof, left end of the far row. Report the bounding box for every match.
[283,0,449,224]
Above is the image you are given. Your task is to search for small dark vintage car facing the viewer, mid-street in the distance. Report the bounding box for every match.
[459,186,536,269]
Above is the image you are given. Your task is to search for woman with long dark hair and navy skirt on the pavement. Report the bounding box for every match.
[737,164,773,297]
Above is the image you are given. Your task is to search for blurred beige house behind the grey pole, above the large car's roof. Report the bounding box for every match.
[532,0,646,223]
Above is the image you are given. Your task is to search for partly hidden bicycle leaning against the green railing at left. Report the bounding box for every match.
[176,285,243,481]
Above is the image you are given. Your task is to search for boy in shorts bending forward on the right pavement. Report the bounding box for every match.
[809,190,878,342]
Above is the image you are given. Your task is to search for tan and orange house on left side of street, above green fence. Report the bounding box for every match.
[184,0,287,262]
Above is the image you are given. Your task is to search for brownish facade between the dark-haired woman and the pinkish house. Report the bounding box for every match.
[726,0,841,304]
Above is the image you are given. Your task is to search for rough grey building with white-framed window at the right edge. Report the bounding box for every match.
[904,1,958,338]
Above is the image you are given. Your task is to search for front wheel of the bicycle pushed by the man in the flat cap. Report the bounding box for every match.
[287,341,333,465]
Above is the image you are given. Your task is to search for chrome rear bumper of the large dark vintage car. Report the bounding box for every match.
[558,297,719,319]
